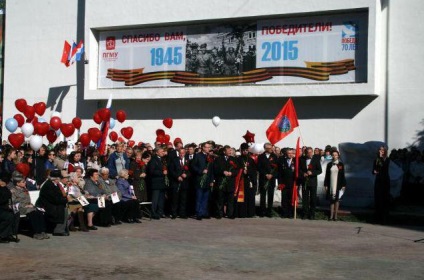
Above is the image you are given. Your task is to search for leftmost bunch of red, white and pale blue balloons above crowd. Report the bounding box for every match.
[5,98,82,151]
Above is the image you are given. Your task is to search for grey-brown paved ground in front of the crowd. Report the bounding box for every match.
[0,218,424,280]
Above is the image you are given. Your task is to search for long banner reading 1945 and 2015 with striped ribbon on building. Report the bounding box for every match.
[98,12,368,88]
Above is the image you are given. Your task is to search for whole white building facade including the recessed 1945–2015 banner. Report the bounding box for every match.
[3,0,424,151]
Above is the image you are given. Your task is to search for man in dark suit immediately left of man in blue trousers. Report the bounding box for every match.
[168,147,190,219]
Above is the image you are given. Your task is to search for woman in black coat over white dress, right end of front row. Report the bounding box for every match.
[324,151,346,221]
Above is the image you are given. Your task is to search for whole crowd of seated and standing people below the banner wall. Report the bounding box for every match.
[0,138,423,243]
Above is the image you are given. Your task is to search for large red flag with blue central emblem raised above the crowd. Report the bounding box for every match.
[266,98,299,145]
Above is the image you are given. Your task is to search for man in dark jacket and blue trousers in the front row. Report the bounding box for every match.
[191,142,213,220]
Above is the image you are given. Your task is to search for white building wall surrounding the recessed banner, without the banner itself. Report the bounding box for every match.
[3,0,423,151]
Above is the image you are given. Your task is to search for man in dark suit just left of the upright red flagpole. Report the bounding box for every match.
[278,148,295,218]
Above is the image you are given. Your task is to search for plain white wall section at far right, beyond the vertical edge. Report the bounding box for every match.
[387,0,424,149]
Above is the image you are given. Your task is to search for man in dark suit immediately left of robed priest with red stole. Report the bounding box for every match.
[213,146,239,219]
